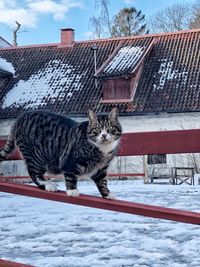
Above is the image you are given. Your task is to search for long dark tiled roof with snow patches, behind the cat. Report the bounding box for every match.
[0,30,200,118]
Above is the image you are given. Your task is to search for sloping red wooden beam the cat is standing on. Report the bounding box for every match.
[0,182,200,224]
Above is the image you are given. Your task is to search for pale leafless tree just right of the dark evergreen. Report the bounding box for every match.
[148,3,191,32]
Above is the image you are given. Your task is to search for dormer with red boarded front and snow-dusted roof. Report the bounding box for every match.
[95,39,158,103]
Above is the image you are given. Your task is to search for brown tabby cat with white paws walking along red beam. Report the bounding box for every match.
[0,108,122,199]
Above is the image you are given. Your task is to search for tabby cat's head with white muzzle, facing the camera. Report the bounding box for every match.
[87,108,122,145]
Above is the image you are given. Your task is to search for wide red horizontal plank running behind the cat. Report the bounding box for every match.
[0,129,200,160]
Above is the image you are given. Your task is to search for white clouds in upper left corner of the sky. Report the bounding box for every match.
[0,0,83,28]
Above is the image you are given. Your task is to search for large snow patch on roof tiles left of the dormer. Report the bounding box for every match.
[2,60,84,109]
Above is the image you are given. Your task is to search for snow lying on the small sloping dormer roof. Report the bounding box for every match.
[104,46,145,73]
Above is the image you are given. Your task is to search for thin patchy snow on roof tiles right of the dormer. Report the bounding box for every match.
[153,59,188,92]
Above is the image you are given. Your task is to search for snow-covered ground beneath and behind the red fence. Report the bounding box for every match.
[0,181,200,267]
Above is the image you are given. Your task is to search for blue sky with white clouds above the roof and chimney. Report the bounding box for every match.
[0,0,194,45]
